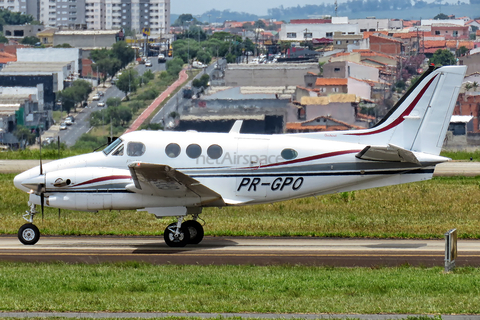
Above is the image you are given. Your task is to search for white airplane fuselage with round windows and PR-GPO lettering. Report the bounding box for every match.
[14,131,433,211]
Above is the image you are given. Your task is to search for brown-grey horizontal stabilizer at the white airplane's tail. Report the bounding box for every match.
[355,144,421,166]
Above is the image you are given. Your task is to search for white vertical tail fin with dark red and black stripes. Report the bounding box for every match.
[342,66,466,155]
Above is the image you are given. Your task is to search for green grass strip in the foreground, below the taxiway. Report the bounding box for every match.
[0,262,480,314]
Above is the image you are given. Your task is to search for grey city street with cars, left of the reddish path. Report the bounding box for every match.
[58,57,166,147]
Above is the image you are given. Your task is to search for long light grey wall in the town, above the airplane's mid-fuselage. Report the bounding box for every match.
[225,63,320,87]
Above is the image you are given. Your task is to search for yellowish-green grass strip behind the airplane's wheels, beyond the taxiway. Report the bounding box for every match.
[0,174,480,239]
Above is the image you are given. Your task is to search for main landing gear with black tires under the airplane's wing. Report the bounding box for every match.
[163,215,203,247]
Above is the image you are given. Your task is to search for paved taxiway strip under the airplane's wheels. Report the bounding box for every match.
[0,236,480,267]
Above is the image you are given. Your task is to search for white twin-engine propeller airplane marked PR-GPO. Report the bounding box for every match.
[14,66,466,247]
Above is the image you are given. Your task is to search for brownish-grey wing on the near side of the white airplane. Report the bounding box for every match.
[127,162,225,206]
